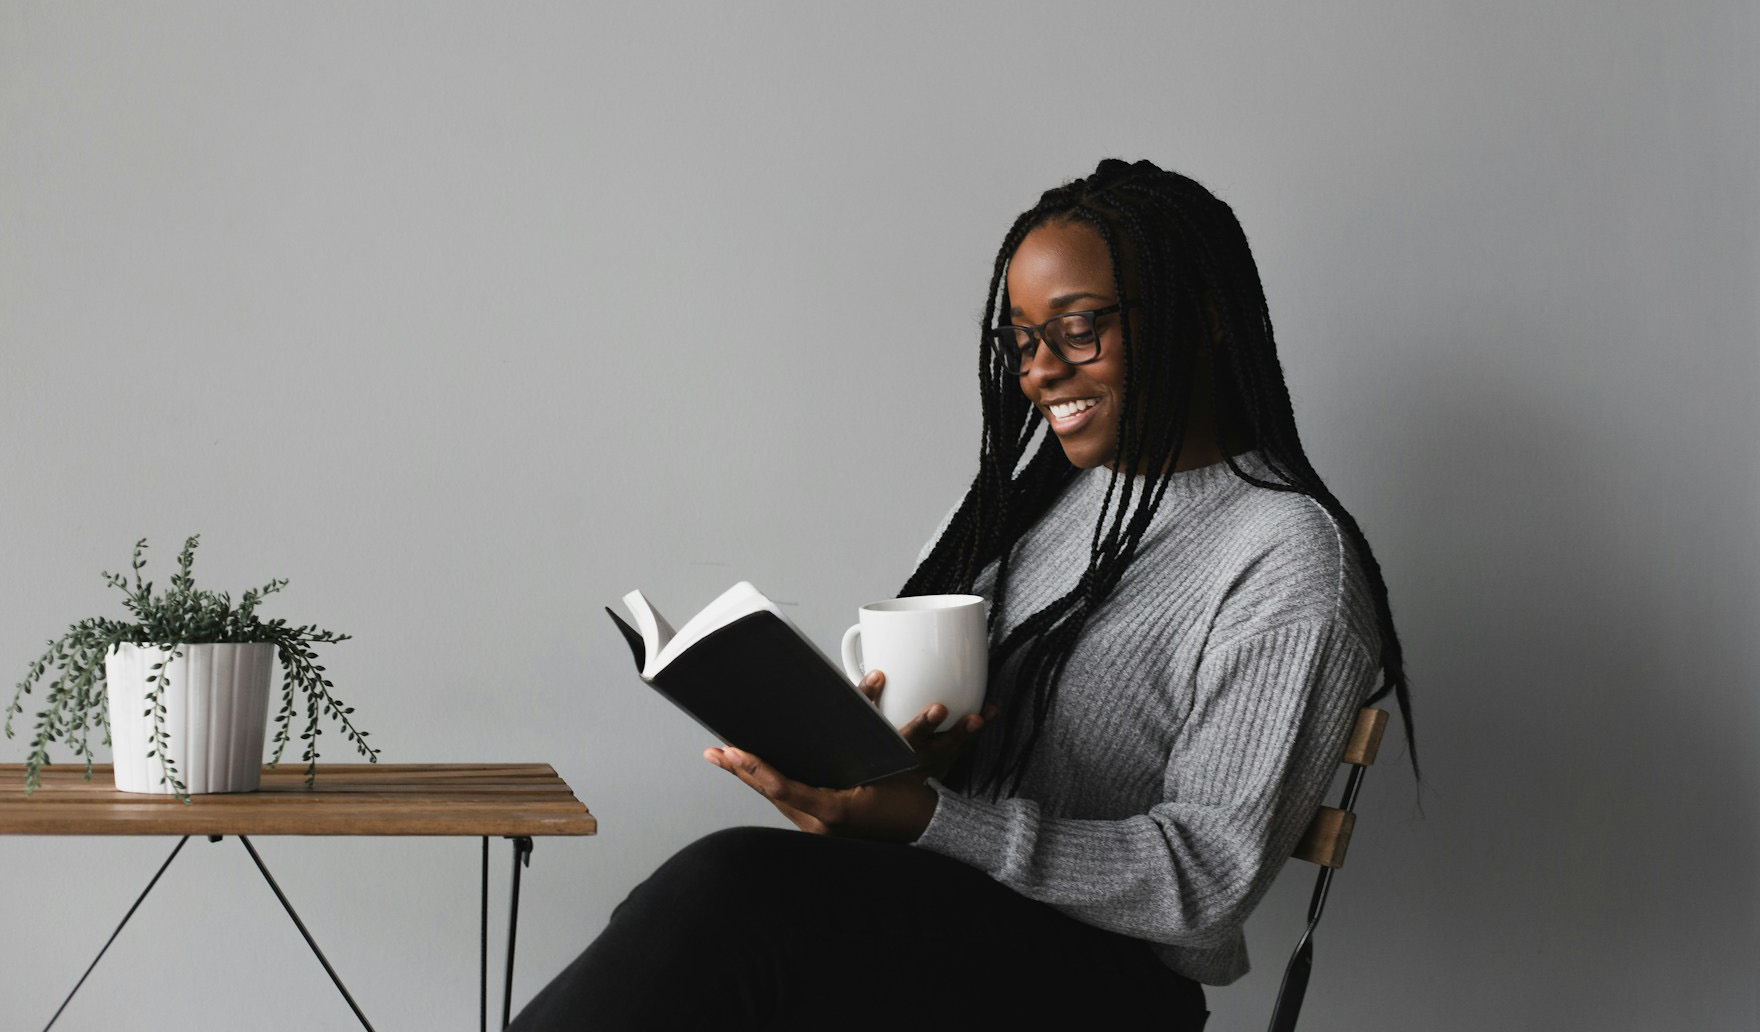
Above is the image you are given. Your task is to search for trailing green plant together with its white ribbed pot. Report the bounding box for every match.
[5,535,378,803]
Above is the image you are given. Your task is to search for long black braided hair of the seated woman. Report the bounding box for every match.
[899,158,1417,796]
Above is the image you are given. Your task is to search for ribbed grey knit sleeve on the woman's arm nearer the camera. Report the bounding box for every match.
[917,622,1376,981]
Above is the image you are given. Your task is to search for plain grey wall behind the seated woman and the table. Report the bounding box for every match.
[0,0,1760,1032]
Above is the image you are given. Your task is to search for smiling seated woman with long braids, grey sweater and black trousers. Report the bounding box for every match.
[516,158,1412,1028]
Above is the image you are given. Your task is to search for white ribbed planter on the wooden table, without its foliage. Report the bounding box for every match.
[104,643,275,796]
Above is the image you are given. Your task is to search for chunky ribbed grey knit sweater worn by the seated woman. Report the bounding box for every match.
[917,453,1380,984]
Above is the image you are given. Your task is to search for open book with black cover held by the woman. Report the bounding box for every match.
[605,581,917,789]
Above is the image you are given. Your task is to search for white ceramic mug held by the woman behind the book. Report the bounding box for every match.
[843,595,989,731]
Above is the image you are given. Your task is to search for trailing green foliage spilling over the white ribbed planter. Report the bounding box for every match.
[5,534,378,803]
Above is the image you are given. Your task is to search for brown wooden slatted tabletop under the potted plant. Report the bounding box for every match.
[0,763,598,837]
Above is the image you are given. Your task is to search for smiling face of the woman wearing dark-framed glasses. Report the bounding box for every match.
[1007,222,1125,470]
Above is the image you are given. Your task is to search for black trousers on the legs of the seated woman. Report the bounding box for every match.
[512,828,1206,1032]
